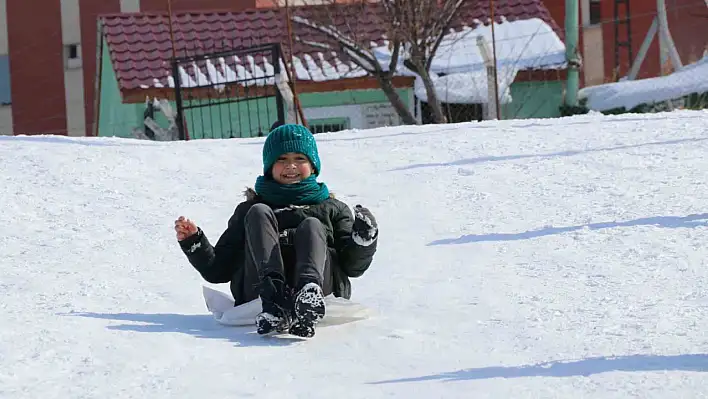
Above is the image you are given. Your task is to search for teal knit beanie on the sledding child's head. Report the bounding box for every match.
[263,124,320,176]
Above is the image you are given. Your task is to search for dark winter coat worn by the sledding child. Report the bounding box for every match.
[180,189,377,305]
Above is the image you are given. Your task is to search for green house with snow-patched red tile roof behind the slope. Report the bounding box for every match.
[94,0,565,138]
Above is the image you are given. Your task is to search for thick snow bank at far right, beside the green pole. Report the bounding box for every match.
[578,56,708,111]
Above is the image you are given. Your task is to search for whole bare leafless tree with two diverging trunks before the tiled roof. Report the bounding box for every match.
[284,0,471,124]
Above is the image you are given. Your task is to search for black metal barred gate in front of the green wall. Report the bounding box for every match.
[172,44,285,140]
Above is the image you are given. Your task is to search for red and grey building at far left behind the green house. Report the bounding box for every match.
[0,0,268,136]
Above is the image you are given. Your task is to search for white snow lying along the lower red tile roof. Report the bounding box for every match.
[163,18,566,89]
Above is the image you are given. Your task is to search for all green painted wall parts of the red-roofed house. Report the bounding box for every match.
[98,39,564,139]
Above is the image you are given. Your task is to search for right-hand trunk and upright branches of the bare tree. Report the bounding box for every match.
[381,0,467,123]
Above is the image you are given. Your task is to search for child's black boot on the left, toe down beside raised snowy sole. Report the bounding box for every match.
[256,276,294,334]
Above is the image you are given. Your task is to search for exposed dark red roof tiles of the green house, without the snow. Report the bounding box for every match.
[99,0,563,89]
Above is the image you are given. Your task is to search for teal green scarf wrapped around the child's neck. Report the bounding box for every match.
[256,175,329,206]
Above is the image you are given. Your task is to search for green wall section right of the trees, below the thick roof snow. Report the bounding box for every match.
[501,80,564,119]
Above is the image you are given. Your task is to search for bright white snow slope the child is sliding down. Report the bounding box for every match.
[0,111,708,399]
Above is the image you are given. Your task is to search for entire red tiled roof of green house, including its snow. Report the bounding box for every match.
[100,0,564,89]
